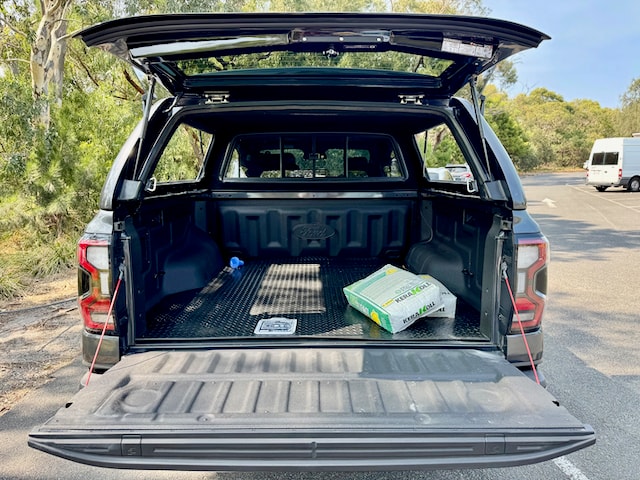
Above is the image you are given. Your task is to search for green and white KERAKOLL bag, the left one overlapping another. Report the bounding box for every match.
[343,265,443,333]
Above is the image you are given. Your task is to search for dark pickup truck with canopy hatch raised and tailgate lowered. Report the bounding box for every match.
[29,13,595,471]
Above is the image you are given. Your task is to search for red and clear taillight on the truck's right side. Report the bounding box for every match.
[511,237,549,332]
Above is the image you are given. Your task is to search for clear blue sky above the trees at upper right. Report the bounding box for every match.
[483,0,640,108]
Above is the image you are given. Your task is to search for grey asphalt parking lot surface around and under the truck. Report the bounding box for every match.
[0,173,640,480]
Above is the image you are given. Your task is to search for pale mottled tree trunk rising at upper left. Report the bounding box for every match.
[30,0,73,127]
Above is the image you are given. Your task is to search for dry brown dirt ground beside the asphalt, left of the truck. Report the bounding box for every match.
[0,270,82,415]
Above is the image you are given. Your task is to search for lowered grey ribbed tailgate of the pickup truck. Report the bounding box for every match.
[29,347,595,471]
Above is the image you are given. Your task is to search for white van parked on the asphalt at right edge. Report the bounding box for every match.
[586,134,640,192]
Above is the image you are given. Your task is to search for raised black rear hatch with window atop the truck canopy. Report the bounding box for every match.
[75,13,549,97]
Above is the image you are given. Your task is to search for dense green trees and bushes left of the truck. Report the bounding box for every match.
[0,1,141,296]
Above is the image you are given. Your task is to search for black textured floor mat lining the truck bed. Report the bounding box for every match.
[137,257,480,343]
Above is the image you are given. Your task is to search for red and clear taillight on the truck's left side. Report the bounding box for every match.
[78,238,115,332]
